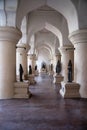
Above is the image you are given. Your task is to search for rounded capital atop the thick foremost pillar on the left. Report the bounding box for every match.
[0,26,22,43]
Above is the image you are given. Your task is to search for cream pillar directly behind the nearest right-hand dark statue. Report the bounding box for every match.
[59,46,74,82]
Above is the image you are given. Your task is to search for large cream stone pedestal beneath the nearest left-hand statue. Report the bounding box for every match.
[14,82,31,98]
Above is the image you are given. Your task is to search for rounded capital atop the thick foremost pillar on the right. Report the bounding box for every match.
[69,29,87,45]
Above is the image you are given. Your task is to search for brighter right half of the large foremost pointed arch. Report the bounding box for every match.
[47,0,79,33]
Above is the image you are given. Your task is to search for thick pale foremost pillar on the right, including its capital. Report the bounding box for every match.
[69,29,87,98]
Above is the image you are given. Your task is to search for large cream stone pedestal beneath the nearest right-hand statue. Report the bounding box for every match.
[60,82,80,98]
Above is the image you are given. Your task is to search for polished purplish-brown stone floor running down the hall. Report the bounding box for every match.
[0,76,87,130]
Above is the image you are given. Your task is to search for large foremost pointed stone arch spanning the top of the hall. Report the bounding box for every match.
[17,0,79,33]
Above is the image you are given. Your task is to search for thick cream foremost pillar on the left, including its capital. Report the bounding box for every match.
[0,27,22,99]
